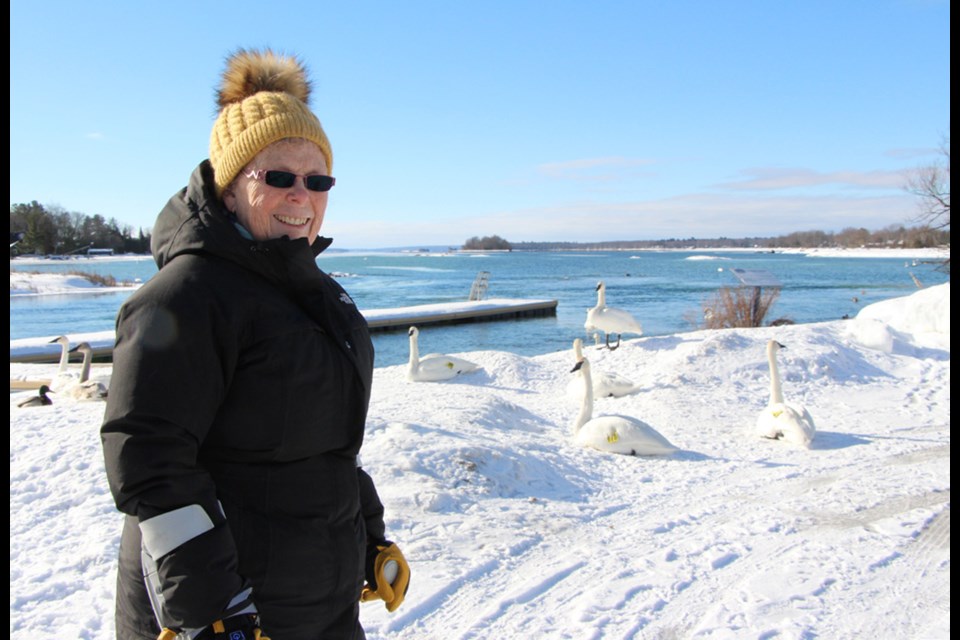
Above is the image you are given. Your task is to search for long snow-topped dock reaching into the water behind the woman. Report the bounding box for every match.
[10,298,557,364]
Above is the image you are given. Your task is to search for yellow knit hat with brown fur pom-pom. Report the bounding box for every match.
[210,49,333,196]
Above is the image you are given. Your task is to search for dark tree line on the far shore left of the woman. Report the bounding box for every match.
[10,200,150,257]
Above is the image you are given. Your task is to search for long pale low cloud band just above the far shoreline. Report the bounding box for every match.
[325,189,915,247]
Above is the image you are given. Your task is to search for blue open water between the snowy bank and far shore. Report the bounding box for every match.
[10,251,949,366]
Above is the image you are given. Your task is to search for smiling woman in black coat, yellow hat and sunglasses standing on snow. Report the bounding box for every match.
[101,50,409,640]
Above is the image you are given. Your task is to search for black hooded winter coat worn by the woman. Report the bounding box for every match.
[101,161,384,640]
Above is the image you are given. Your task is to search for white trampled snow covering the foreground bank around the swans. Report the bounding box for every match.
[10,272,950,640]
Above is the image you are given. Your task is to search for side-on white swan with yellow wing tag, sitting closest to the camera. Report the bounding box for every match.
[573,358,679,456]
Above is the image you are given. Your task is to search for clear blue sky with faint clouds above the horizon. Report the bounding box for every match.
[10,0,950,248]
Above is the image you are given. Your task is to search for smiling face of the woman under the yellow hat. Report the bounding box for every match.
[223,138,330,242]
